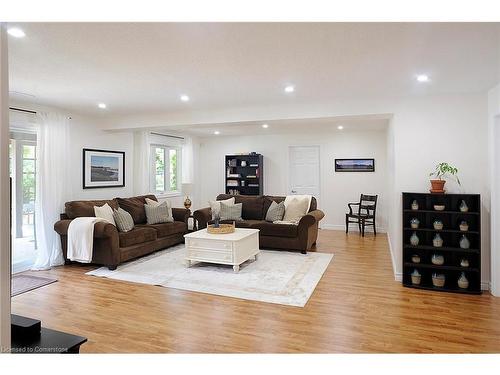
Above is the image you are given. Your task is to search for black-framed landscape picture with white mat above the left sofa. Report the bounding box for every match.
[83,148,125,189]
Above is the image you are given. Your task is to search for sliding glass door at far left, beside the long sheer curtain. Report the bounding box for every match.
[10,133,36,273]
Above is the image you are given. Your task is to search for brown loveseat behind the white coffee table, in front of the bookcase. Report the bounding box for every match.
[193,194,325,254]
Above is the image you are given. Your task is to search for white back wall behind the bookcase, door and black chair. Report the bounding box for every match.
[200,128,388,231]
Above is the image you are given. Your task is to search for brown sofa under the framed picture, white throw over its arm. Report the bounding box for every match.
[54,195,189,270]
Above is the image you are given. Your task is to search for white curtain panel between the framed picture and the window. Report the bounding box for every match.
[133,131,150,195]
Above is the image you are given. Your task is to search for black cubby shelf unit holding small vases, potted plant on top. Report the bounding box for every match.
[402,193,481,294]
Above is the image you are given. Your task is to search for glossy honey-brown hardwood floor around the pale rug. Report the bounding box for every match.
[12,230,500,353]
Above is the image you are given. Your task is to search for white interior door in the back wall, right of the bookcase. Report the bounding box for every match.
[288,146,320,199]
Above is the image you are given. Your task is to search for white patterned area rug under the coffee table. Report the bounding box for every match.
[87,245,333,307]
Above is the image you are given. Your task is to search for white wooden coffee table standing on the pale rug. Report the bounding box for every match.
[184,228,260,272]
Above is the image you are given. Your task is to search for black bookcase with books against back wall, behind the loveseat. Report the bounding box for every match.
[225,154,264,195]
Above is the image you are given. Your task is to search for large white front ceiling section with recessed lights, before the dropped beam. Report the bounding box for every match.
[9,23,500,115]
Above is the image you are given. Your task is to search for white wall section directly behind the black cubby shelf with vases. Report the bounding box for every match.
[390,93,490,286]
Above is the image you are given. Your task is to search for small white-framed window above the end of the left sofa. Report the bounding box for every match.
[150,145,181,194]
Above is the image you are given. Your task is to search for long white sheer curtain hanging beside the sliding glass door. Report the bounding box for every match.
[33,112,70,270]
